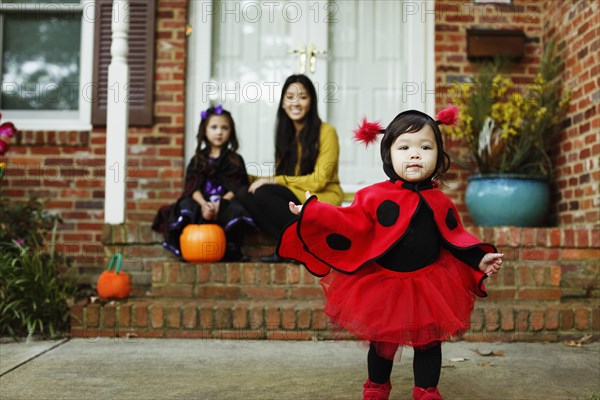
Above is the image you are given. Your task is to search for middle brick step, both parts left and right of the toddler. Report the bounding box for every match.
[146,260,561,301]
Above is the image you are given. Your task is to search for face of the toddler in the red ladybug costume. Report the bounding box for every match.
[390,125,438,182]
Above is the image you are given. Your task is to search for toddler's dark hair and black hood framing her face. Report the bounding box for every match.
[381,110,450,180]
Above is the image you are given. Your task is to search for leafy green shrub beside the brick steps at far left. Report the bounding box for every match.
[0,198,77,338]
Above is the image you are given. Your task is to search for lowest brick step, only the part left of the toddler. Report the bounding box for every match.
[71,298,332,340]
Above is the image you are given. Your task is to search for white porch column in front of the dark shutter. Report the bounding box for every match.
[104,0,129,224]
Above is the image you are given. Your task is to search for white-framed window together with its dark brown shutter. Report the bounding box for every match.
[0,0,156,131]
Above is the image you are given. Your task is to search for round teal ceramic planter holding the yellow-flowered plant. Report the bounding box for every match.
[465,174,550,226]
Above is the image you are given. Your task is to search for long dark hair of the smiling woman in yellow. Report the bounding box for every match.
[275,75,321,176]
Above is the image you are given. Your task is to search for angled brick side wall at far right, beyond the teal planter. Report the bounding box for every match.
[543,0,600,227]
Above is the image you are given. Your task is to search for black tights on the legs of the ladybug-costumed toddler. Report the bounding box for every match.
[367,342,442,388]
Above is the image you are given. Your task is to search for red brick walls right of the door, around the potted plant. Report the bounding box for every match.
[435,0,600,227]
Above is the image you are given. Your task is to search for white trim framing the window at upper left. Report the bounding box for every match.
[0,0,95,131]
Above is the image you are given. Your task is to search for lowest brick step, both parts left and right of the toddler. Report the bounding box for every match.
[71,298,600,341]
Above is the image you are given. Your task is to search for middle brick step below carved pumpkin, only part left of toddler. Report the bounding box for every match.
[150,261,323,301]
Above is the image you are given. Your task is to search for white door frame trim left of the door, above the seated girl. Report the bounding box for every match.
[184,0,213,165]
